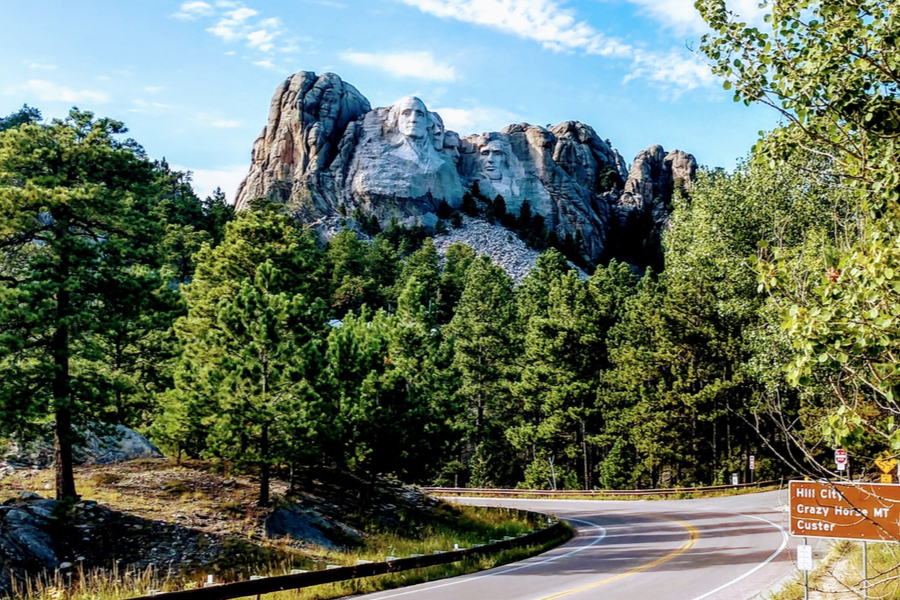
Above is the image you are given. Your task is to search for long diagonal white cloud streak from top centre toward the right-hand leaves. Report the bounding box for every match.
[400,0,716,93]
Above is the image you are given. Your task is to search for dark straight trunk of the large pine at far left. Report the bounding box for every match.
[52,219,78,500]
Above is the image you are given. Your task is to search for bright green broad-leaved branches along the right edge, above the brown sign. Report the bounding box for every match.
[697,0,900,468]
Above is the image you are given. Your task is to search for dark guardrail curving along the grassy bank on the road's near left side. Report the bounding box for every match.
[130,511,565,600]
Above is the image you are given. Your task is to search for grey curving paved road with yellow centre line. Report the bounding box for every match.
[356,492,796,600]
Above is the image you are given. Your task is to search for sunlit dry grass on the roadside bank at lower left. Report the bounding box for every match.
[0,461,570,600]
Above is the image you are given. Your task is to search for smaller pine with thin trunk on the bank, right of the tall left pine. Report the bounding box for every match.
[201,261,331,506]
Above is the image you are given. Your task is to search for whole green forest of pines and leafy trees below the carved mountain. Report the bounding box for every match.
[0,0,900,504]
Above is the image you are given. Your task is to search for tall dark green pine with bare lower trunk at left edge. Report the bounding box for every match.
[0,110,161,499]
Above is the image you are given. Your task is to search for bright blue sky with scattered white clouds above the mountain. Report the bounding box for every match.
[0,0,776,199]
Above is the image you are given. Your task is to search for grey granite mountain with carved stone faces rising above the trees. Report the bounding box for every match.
[236,71,697,263]
